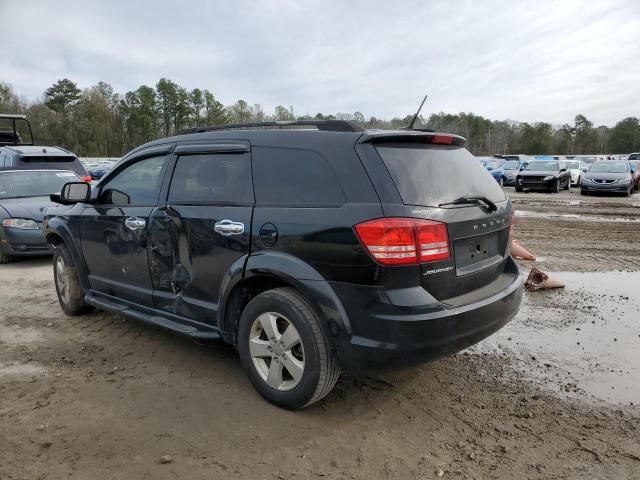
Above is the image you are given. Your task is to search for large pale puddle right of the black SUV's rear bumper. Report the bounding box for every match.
[478,272,640,404]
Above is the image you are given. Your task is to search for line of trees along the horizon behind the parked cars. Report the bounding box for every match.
[0,78,640,157]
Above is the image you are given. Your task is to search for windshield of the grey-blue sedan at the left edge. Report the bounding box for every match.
[0,170,80,199]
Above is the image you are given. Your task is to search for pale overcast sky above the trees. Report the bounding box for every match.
[0,0,640,125]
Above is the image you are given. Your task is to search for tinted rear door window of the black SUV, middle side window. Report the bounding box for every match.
[169,153,253,203]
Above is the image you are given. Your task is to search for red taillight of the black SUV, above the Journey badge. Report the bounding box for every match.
[354,218,449,265]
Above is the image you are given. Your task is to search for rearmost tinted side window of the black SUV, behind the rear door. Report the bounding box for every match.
[253,147,345,206]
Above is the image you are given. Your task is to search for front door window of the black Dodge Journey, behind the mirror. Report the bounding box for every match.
[100,156,166,205]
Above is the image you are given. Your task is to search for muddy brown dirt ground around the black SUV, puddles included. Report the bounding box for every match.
[0,188,640,480]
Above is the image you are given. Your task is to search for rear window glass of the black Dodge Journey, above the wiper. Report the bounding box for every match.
[377,144,506,206]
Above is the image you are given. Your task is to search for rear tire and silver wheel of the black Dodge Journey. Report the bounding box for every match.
[238,288,340,410]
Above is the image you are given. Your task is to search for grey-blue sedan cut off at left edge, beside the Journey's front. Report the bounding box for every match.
[0,170,81,264]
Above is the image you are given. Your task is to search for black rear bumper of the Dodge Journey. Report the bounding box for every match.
[332,259,523,372]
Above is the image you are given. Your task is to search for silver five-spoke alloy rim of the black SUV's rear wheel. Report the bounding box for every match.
[249,312,305,391]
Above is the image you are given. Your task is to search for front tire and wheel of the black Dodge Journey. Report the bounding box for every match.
[53,244,91,317]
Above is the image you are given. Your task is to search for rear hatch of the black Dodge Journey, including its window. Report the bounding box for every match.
[375,136,512,304]
